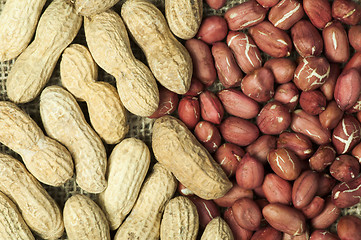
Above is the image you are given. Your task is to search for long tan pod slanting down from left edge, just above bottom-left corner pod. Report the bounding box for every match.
[0,153,64,239]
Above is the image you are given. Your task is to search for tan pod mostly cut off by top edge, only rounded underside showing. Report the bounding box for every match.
[74,0,119,16]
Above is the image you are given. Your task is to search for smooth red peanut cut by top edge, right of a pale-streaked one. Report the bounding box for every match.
[303,0,332,29]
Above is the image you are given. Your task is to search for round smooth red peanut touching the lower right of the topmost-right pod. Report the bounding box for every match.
[196,16,228,44]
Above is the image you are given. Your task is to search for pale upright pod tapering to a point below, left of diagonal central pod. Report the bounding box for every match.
[99,138,150,230]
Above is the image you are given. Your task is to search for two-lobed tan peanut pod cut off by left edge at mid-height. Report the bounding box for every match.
[0,101,74,186]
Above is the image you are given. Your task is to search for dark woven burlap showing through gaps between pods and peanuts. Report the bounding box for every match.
[0,0,361,240]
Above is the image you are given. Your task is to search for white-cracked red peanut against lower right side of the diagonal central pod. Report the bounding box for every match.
[214,143,245,177]
